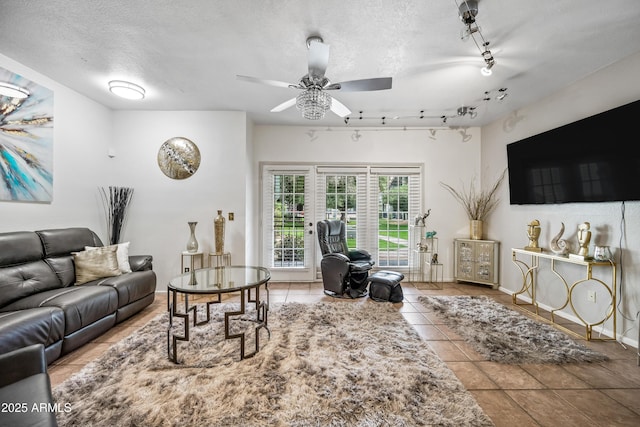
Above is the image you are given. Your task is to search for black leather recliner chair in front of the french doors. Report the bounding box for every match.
[317,219,375,298]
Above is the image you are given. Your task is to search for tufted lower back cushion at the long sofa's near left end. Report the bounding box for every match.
[0,260,62,307]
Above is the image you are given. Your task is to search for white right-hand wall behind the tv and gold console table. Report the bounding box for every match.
[482,51,640,346]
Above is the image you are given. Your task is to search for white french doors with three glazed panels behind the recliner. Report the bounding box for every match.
[262,165,421,281]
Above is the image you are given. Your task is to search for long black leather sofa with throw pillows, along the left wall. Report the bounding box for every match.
[0,228,156,364]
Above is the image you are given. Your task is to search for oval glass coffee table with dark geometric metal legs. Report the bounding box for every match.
[167,266,271,363]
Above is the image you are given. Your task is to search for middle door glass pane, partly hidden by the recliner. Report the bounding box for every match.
[325,175,358,249]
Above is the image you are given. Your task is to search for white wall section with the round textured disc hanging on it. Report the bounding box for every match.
[109,111,250,290]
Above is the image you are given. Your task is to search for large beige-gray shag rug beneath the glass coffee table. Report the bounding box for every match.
[53,301,493,427]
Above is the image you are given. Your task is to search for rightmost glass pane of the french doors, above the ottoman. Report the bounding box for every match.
[378,175,409,267]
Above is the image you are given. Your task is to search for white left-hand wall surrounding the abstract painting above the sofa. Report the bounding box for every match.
[0,55,113,233]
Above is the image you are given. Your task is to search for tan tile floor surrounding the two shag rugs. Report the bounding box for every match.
[49,282,640,427]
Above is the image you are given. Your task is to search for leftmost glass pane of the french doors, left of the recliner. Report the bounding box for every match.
[272,174,305,267]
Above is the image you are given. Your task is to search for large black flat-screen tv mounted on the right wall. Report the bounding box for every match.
[507,101,640,205]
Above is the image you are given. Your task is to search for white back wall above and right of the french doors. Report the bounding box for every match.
[252,126,482,280]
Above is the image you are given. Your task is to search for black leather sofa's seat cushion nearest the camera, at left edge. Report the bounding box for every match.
[0,307,64,353]
